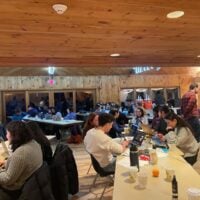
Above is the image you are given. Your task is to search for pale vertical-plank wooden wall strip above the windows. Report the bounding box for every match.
[0,75,194,102]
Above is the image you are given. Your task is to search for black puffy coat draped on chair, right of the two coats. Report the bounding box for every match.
[51,144,79,200]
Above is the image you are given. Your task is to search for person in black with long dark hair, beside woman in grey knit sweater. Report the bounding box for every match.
[26,121,52,165]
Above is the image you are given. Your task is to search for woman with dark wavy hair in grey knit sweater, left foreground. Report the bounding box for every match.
[0,121,43,200]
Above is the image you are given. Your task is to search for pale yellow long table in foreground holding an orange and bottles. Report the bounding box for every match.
[113,147,200,200]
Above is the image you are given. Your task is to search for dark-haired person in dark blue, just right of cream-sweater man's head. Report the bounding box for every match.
[108,110,124,138]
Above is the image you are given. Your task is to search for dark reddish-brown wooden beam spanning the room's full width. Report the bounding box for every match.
[0,57,200,67]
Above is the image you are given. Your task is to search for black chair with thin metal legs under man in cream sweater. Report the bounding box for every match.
[90,154,114,200]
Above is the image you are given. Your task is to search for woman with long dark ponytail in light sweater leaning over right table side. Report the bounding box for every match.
[164,111,199,165]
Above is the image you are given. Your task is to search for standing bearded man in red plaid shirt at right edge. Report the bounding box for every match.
[181,83,200,142]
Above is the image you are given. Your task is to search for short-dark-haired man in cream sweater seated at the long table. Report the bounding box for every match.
[84,113,128,172]
